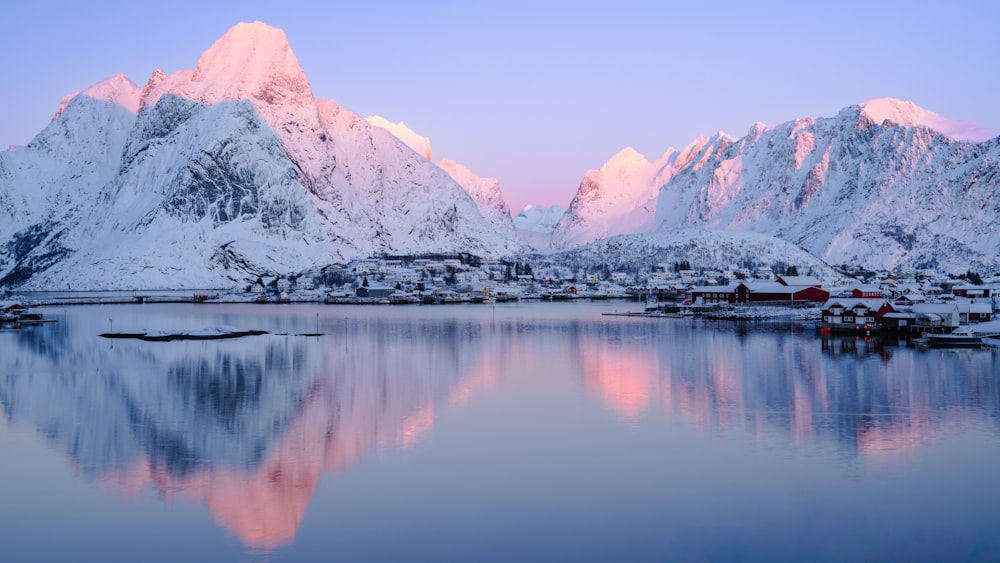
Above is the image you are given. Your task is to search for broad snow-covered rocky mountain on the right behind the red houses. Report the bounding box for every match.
[553,99,1000,272]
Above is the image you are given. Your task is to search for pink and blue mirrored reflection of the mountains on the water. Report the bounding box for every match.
[0,306,1000,549]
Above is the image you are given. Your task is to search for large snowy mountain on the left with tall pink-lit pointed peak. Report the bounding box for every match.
[0,22,520,289]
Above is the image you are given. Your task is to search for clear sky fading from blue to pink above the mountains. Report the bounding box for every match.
[0,0,1000,213]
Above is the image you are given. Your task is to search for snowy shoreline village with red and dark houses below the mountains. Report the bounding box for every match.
[0,255,1000,344]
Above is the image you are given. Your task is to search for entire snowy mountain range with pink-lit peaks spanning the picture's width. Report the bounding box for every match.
[0,22,1000,289]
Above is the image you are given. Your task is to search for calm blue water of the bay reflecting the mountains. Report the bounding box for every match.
[0,303,1000,561]
